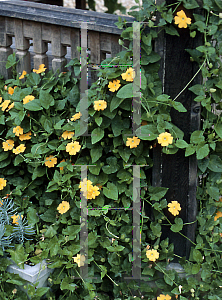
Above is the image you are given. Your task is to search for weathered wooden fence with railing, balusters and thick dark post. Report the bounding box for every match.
[0,0,201,257]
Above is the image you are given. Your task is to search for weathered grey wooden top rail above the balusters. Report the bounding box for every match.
[0,0,133,35]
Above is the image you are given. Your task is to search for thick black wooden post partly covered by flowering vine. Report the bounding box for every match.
[152,0,202,261]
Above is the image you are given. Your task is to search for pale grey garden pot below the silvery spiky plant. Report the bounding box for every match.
[7,259,54,293]
